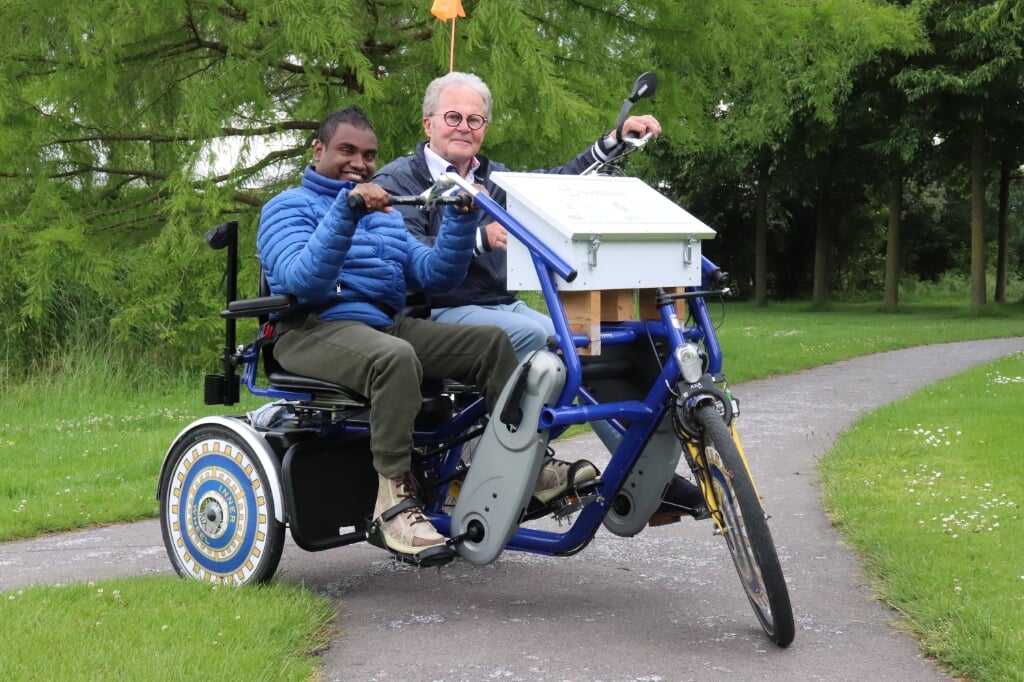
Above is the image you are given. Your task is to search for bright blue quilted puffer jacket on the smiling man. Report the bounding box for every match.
[256,166,479,328]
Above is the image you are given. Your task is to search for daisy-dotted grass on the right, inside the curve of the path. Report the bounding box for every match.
[819,352,1024,681]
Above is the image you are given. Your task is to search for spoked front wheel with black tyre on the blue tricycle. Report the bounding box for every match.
[696,406,796,646]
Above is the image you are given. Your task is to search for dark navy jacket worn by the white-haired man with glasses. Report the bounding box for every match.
[373,141,604,308]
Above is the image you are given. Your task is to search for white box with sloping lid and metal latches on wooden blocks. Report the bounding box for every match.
[490,173,715,291]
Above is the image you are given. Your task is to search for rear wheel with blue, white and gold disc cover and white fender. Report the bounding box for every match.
[160,424,285,585]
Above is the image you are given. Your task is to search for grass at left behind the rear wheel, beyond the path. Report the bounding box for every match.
[0,373,259,541]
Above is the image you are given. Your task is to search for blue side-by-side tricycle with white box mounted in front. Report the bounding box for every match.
[158,73,795,646]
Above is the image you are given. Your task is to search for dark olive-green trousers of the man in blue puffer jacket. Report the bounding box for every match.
[273,314,516,478]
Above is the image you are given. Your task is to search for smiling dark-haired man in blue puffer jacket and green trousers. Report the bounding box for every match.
[256,109,516,565]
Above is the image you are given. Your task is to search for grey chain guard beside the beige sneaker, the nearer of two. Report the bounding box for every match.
[451,350,565,565]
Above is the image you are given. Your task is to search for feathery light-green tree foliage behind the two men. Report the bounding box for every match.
[0,0,933,374]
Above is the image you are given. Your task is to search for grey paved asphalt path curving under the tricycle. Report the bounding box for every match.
[0,338,1024,682]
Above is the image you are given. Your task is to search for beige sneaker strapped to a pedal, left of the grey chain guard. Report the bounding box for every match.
[374,472,444,556]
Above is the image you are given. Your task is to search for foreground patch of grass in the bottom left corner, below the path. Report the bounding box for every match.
[0,577,334,682]
